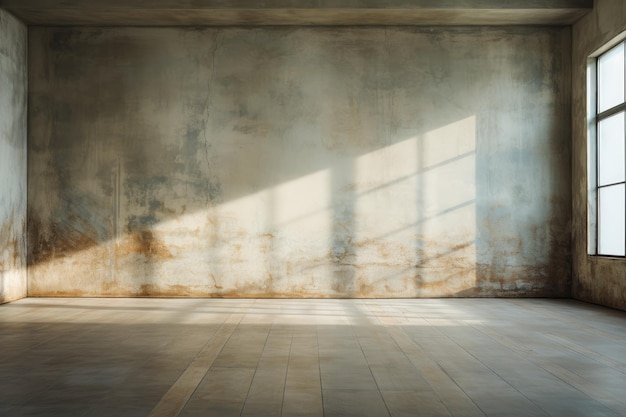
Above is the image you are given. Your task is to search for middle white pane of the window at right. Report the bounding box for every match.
[598,112,626,185]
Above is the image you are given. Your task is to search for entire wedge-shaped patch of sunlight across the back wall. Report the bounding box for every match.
[25,117,476,297]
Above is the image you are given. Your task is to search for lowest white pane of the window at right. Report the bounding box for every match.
[598,184,626,256]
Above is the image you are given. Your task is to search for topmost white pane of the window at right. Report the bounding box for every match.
[598,43,624,113]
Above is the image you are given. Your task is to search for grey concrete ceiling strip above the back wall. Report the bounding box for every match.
[0,0,593,26]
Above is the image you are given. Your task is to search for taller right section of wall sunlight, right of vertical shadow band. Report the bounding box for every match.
[355,116,476,296]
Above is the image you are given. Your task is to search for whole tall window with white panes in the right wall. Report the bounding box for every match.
[590,41,626,257]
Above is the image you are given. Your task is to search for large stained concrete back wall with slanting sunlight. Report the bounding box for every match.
[28,27,571,297]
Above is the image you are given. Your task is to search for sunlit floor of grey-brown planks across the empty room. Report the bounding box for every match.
[0,298,626,417]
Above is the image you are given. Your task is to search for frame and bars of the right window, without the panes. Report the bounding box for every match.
[587,32,626,259]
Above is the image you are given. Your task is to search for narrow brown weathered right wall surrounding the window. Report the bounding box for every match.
[572,0,626,310]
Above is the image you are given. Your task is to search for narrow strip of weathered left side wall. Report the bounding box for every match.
[0,10,28,303]
